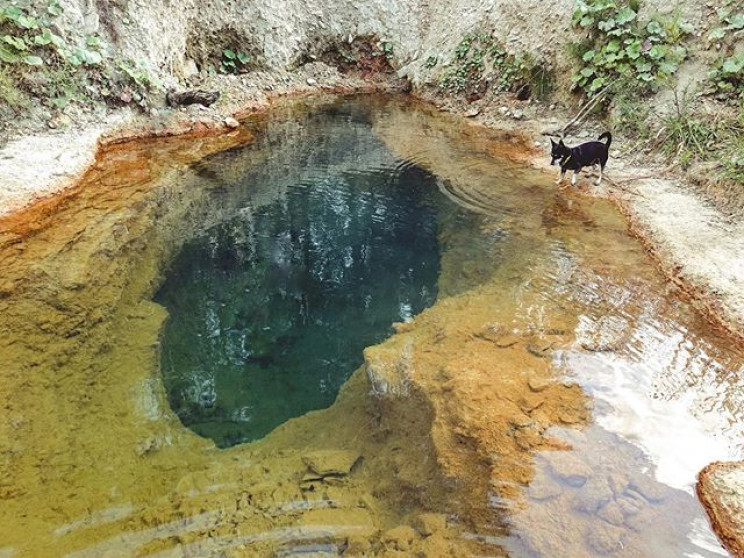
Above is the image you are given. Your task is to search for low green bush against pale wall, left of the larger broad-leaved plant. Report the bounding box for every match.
[438,31,552,97]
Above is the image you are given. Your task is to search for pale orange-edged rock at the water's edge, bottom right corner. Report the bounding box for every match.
[695,461,744,558]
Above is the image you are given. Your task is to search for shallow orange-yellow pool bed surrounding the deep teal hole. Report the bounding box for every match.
[0,94,744,558]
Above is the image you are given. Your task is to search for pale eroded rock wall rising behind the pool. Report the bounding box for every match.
[53,0,703,84]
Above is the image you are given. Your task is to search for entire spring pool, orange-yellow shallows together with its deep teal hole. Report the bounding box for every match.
[0,96,744,558]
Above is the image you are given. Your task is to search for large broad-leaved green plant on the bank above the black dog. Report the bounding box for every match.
[572,0,693,96]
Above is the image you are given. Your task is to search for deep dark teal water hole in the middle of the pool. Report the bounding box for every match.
[156,104,453,447]
